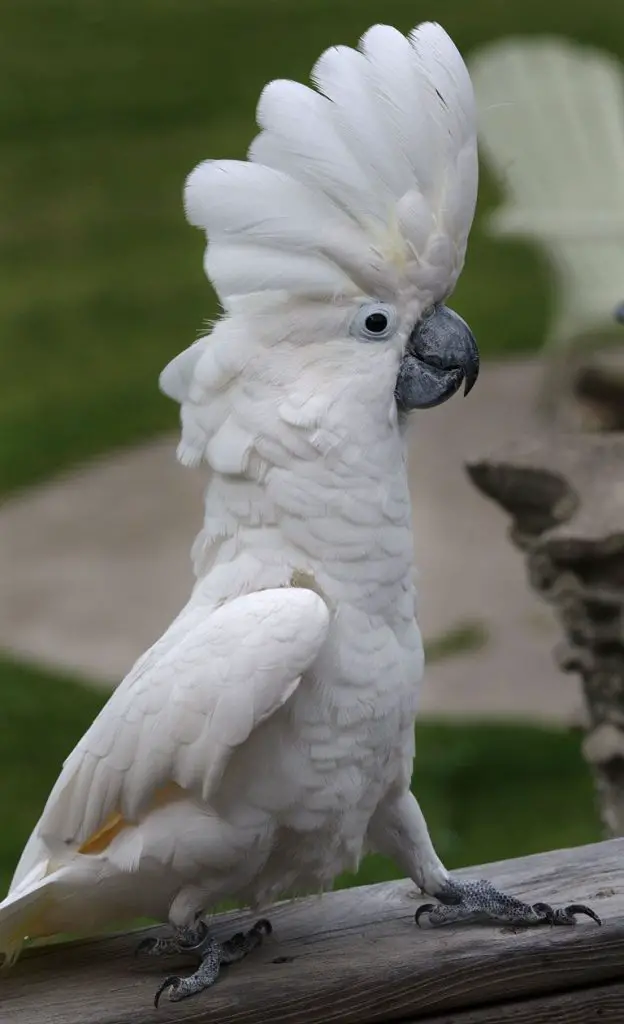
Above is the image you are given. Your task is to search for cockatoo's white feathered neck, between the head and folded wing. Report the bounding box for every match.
[193,397,413,616]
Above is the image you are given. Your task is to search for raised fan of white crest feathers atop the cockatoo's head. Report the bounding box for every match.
[185,24,477,309]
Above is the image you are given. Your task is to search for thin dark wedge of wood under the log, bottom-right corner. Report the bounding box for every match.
[413,981,624,1024]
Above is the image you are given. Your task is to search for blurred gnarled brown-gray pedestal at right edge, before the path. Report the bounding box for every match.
[468,433,624,836]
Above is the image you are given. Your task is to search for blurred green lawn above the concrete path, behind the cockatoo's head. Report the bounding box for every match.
[0,0,624,494]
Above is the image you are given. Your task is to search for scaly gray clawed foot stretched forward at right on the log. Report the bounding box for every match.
[414,879,600,927]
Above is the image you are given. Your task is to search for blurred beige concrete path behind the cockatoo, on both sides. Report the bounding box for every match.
[0,362,581,722]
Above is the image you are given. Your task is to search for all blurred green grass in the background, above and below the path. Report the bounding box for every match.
[0,0,624,897]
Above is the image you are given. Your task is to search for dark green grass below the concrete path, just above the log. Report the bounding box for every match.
[0,658,600,892]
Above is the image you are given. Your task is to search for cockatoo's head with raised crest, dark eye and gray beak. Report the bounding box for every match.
[161,24,479,464]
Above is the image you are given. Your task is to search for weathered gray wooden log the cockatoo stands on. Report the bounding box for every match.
[0,839,624,1024]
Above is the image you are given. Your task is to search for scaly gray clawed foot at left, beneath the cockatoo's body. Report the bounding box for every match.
[136,920,273,1007]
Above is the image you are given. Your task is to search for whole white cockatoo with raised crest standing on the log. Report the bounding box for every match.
[0,24,591,999]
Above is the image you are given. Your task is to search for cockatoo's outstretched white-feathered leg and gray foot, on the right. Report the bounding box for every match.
[369,792,600,927]
